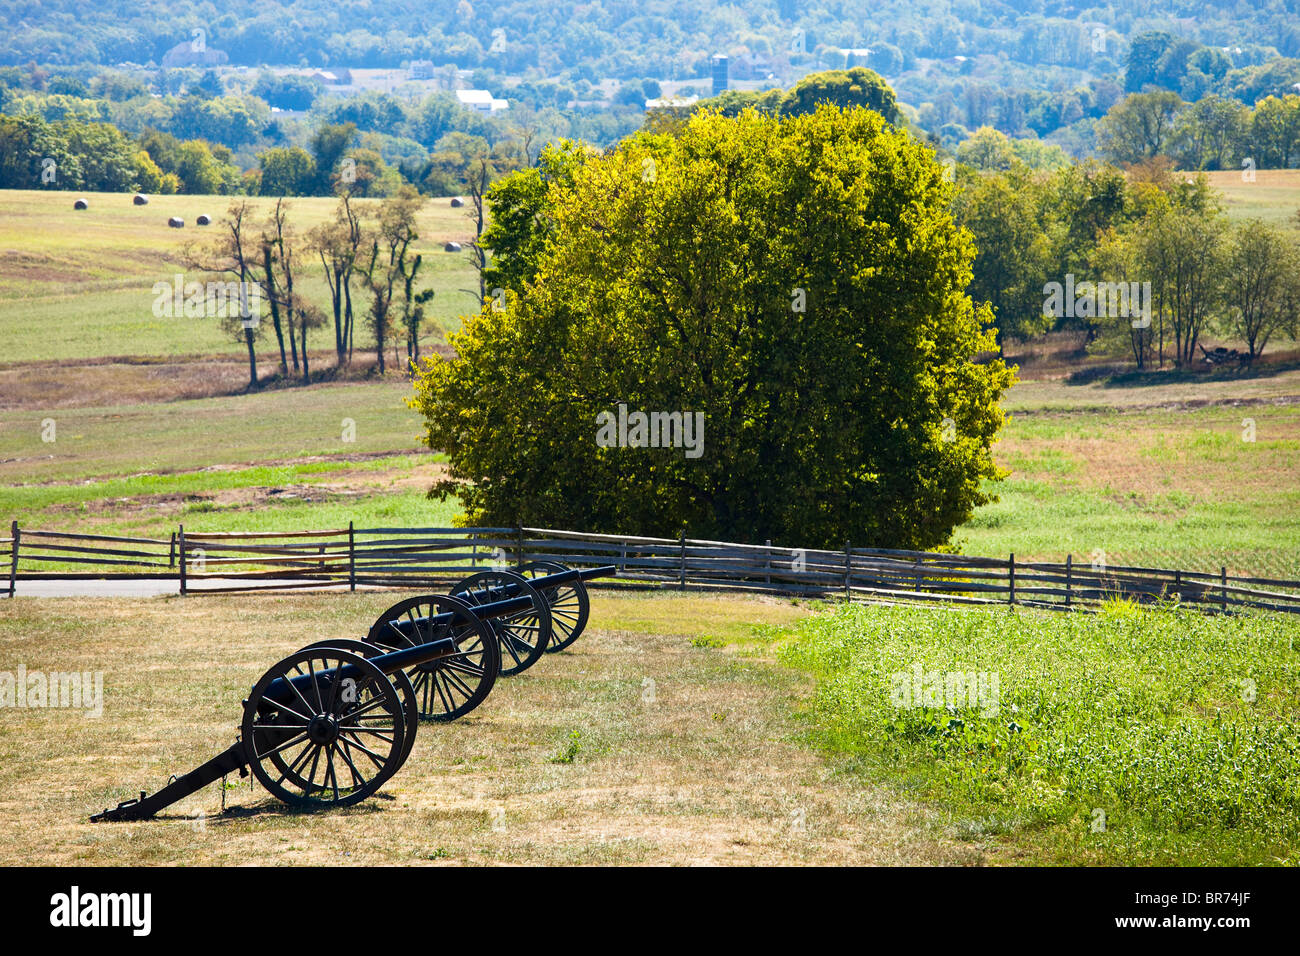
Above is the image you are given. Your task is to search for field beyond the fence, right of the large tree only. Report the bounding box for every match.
[954,371,1300,579]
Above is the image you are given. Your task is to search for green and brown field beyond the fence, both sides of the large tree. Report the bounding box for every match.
[0,369,1300,578]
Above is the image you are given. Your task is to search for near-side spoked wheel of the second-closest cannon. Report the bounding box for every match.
[365,594,501,721]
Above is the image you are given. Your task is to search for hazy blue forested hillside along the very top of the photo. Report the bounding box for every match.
[0,0,1300,77]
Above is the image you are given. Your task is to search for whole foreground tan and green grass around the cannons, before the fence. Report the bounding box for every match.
[0,592,1300,865]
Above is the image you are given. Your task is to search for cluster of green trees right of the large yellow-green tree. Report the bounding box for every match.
[953,129,1300,368]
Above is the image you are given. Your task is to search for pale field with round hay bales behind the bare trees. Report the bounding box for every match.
[0,190,478,363]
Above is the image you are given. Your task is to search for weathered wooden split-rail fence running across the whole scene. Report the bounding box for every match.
[0,522,1300,613]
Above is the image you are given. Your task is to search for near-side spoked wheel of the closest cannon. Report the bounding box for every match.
[241,648,406,808]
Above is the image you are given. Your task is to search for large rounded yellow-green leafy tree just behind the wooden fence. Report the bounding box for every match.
[415,107,1013,548]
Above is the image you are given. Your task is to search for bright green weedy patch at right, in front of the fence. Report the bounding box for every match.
[780,604,1300,866]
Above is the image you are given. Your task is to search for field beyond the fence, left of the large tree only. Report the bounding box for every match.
[0,380,459,538]
